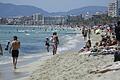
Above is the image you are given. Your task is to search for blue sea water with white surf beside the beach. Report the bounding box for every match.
[0,25,84,55]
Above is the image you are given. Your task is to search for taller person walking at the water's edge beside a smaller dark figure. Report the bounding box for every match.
[52,32,59,55]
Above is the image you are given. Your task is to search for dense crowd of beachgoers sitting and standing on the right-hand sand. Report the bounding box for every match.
[79,21,120,61]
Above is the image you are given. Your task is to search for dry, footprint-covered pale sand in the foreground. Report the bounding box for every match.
[24,53,120,80]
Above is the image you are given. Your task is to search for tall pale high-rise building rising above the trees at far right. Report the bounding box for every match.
[108,0,120,17]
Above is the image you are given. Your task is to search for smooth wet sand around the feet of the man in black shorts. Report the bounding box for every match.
[0,55,50,80]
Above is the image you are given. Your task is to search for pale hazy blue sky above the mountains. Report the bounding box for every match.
[0,0,111,12]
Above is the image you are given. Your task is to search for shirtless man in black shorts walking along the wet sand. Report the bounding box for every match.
[10,36,20,69]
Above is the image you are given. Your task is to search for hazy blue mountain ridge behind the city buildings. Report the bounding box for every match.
[0,3,107,17]
